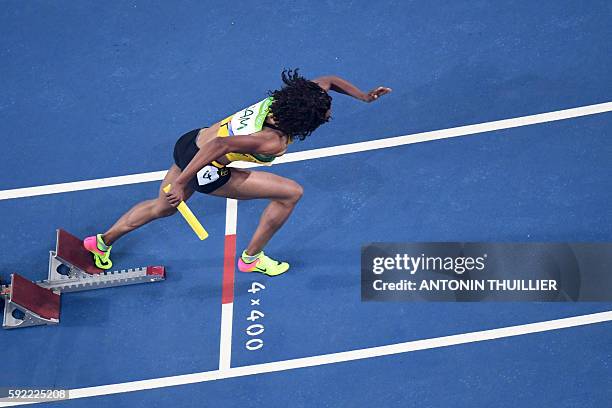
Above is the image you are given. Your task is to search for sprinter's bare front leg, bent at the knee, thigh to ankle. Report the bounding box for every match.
[211,169,303,255]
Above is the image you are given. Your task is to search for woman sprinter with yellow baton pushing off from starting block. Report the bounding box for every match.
[84,69,391,276]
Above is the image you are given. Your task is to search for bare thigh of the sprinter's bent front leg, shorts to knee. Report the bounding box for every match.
[211,169,301,200]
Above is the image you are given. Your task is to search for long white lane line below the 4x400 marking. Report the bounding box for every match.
[0,311,612,407]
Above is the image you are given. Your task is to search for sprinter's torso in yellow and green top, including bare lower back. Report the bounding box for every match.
[197,97,288,165]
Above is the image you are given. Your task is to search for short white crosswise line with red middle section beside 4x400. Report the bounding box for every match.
[219,198,238,371]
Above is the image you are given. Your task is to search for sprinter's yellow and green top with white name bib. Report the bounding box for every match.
[213,97,286,166]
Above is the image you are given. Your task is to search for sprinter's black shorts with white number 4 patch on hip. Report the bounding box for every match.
[174,129,232,194]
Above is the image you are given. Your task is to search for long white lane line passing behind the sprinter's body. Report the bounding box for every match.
[0,102,612,200]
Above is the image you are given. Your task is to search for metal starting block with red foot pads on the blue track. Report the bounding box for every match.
[0,229,166,329]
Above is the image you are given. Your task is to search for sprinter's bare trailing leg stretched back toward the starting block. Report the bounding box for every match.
[102,164,193,245]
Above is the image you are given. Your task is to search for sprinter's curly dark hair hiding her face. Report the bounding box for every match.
[268,69,332,140]
